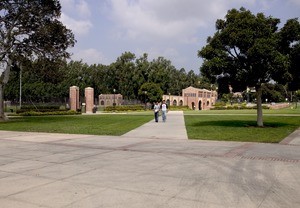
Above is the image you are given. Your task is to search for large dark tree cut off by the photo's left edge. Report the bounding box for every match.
[0,0,75,120]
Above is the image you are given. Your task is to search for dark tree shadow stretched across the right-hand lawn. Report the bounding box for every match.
[191,120,289,128]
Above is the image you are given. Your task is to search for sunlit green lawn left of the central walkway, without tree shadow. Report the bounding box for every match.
[0,114,153,135]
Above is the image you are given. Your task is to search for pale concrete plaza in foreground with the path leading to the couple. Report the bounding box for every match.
[0,113,300,208]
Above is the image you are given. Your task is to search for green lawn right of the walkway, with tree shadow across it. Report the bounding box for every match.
[185,114,300,143]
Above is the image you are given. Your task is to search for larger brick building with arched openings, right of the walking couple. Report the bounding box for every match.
[163,87,218,110]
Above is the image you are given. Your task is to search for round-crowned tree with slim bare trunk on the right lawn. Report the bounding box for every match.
[198,8,291,126]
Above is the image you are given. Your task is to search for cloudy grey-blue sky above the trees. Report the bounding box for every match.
[61,0,300,73]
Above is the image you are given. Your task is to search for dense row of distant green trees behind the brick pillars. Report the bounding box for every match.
[4,52,204,102]
